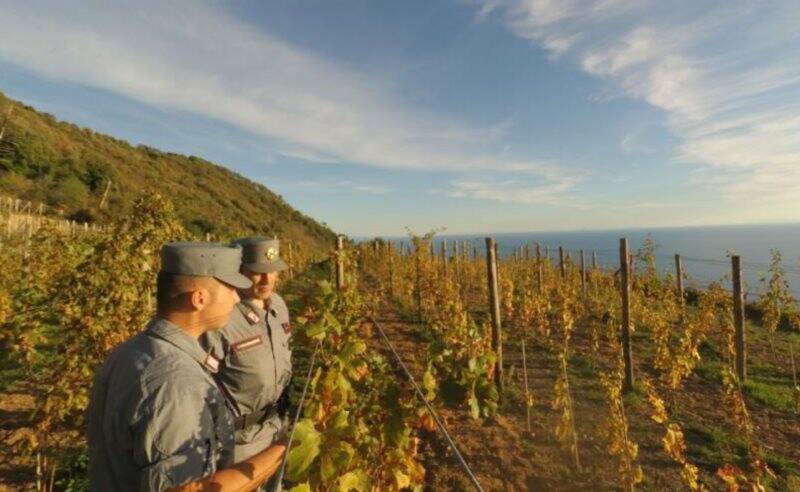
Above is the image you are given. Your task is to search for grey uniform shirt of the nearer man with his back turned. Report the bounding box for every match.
[88,318,233,492]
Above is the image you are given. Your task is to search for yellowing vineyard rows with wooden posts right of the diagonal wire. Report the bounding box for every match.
[350,235,800,490]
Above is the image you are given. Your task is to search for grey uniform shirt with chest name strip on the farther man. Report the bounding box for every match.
[200,294,292,463]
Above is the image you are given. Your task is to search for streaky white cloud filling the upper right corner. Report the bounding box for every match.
[477,0,800,201]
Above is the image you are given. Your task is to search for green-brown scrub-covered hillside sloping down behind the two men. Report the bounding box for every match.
[0,93,335,250]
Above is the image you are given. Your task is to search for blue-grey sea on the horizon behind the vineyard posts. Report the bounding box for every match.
[370,224,800,300]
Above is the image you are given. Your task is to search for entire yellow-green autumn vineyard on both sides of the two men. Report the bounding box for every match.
[0,201,800,492]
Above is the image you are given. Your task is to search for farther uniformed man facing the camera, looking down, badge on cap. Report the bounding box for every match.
[201,237,292,488]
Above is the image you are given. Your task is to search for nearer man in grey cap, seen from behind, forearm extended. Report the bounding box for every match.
[87,243,286,492]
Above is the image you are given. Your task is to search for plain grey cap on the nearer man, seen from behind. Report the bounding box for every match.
[161,242,253,289]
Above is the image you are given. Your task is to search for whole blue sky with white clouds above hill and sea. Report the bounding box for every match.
[0,0,800,236]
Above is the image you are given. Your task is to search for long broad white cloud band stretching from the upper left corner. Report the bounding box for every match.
[0,0,580,205]
